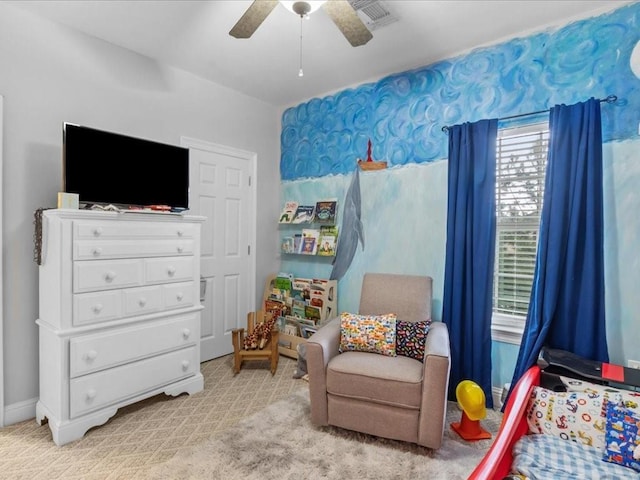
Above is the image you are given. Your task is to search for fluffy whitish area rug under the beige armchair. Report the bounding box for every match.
[145,388,501,480]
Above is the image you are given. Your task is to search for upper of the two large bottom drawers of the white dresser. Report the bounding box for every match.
[69,314,200,378]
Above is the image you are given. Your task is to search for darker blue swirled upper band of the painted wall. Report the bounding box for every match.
[280,5,640,180]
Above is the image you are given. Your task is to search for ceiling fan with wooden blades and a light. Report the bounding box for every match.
[229,0,373,47]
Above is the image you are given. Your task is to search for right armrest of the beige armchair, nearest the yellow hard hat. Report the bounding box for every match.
[418,322,451,448]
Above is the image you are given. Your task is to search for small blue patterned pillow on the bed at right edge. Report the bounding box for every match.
[602,403,640,472]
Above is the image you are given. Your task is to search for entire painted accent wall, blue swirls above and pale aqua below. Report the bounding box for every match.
[280,2,640,386]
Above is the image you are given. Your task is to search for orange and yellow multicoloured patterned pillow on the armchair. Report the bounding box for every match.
[339,312,396,357]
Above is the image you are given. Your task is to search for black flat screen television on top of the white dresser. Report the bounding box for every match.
[62,122,189,209]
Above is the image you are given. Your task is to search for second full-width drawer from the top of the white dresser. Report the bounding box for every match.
[73,239,194,260]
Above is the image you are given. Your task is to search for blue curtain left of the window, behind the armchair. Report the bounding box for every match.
[442,119,498,407]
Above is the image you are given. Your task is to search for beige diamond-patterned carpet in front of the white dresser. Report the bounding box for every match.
[0,355,307,480]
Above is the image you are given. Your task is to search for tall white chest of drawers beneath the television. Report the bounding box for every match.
[36,210,204,445]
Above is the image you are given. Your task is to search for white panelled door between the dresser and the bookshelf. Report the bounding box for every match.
[181,138,256,362]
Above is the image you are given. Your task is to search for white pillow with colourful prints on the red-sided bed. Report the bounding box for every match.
[527,382,638,451]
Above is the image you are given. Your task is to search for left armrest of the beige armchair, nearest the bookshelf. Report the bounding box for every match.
[306,318,340,425]
